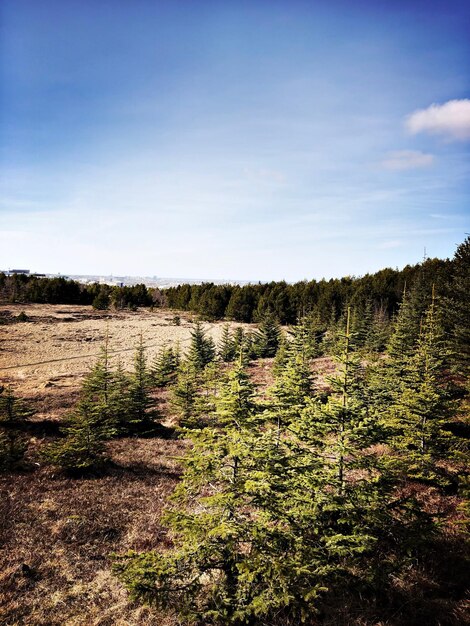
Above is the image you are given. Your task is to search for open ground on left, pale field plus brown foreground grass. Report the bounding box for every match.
[0,305,235,626]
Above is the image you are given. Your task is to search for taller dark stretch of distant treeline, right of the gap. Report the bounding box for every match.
[163,254,454,324]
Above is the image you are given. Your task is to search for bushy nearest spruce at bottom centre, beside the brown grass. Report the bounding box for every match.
[115,361,328,625]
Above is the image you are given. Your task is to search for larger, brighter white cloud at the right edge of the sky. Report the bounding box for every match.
[405,99,470,140]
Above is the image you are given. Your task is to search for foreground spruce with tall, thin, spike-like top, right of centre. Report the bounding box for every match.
[285,310,390,586]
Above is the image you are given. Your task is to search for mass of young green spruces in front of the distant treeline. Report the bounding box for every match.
[0,234,470,626]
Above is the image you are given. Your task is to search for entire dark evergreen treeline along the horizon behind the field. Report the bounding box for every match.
[0,246,458,327]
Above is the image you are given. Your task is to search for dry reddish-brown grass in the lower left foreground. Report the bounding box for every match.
[0,439,185,626]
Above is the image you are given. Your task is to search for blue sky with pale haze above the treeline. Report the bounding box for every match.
[0,0,470,280]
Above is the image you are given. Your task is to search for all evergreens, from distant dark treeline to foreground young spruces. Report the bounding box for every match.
[0,238,470,626]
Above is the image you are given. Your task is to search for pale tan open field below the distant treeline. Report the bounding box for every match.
[0,304,248,396]
